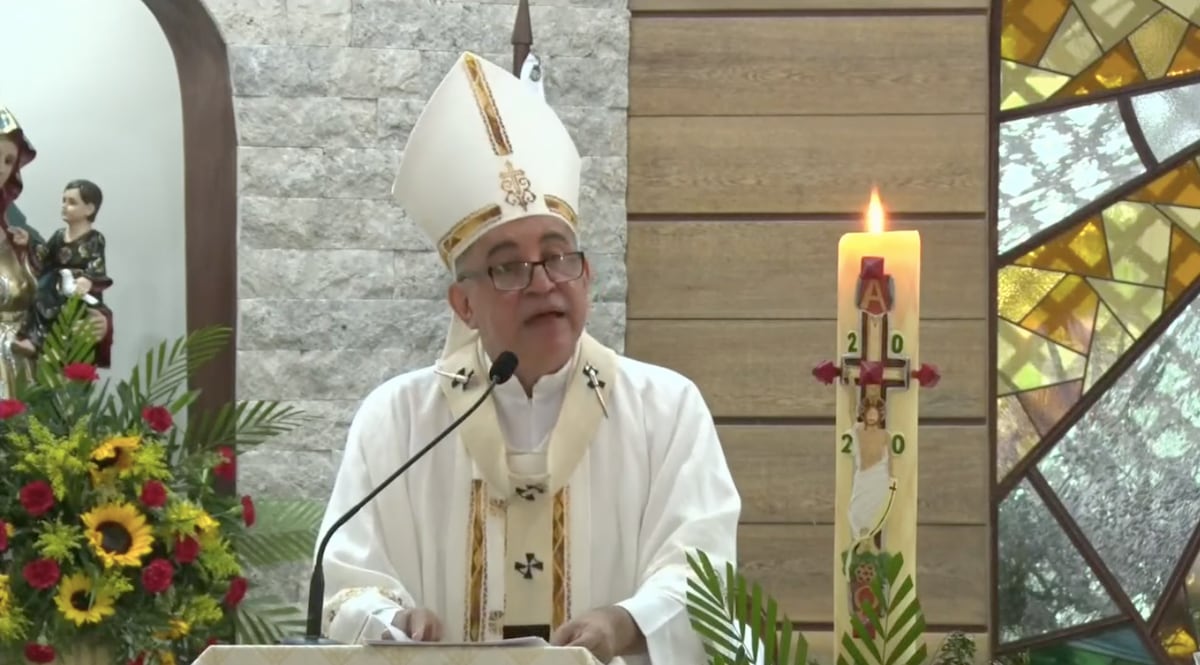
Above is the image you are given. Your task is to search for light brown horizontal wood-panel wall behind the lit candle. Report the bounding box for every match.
[626,0,991,651]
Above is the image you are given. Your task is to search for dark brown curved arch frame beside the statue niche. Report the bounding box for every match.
[143,0,238,409]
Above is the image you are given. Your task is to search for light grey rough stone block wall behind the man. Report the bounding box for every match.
[198,0,629,600]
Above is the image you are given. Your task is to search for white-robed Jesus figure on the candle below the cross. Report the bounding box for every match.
[850,391,892,549]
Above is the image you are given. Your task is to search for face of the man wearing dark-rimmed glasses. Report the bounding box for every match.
[450,216,592,381]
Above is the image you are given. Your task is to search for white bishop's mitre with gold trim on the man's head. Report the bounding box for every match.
[391,53,582,358]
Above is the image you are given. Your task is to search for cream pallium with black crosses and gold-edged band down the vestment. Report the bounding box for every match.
[439,333,617,642]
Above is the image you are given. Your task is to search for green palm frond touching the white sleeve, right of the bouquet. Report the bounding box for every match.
[234,498,325,569]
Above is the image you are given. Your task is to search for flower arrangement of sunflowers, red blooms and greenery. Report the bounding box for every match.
[0,298,312,665]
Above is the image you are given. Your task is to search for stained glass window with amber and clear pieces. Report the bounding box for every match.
[992,0,1200,665]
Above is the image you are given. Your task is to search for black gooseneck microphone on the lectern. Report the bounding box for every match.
[288,351,517,645]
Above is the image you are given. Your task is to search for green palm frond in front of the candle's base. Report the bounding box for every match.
[838,553,929,665]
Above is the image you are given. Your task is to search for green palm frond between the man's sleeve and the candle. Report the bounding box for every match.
[688,551,809,665]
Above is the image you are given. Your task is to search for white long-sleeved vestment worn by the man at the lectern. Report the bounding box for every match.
[322,334,740,665]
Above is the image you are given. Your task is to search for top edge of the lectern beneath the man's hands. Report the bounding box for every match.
[194,643,609,665]
